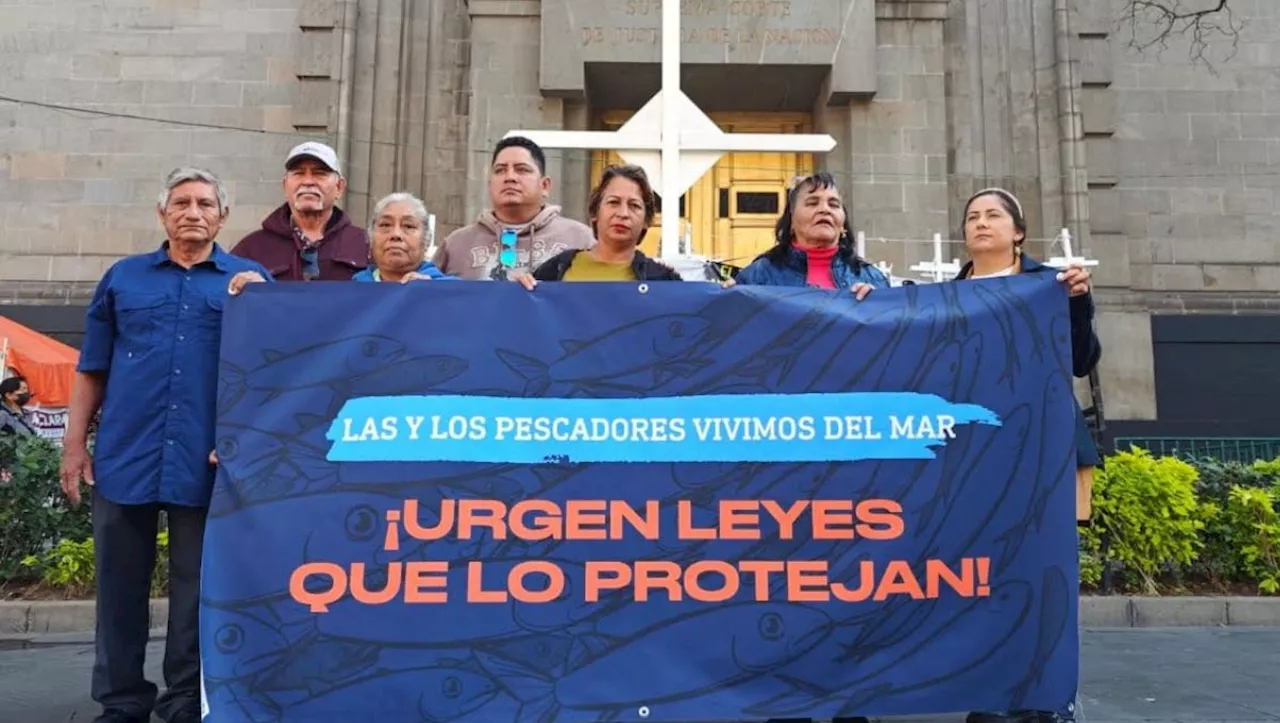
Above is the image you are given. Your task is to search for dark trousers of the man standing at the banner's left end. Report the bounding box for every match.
[91,494,207,722]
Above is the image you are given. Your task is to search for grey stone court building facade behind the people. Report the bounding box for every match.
[0,0,1280,436]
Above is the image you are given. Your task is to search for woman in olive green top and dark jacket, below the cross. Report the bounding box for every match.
[511,165,684,290]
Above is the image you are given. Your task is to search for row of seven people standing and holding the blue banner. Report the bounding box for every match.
[55,138,1101,723]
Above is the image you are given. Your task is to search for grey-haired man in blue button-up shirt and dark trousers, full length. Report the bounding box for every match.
[61,168,271,723]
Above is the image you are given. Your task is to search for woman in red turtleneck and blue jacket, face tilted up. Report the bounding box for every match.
[723,171,890,301]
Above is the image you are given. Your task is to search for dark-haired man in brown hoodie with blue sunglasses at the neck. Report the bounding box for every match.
[433,136,595,280]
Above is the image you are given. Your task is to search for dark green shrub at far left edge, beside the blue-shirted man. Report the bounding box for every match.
[0,435,92,584]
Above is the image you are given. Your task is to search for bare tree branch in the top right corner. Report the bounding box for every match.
[1121,0,1244,72]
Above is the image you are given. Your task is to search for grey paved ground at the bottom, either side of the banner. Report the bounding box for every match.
[0,628,1280,723]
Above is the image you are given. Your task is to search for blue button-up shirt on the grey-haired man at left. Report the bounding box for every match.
[77,242,271,507]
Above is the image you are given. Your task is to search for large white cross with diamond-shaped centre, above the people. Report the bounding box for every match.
[507,0,836,258]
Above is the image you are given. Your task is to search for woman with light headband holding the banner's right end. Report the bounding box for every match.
[956,188,1102,723]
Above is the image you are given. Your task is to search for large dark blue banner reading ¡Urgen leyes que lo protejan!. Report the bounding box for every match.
[201,278,1079,723]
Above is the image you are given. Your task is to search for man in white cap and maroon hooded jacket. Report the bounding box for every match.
[232,141,369,282]
